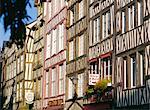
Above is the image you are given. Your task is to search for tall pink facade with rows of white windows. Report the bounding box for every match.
[43,0,67,110]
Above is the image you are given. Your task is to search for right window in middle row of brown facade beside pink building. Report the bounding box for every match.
[78,35,84,56]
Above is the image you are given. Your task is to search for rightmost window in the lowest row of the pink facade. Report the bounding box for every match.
[59,65,65,94]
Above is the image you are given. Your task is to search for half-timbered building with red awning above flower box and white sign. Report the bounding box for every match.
[84,0,115,110]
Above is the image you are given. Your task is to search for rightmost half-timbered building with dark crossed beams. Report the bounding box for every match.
[114,0,150,110]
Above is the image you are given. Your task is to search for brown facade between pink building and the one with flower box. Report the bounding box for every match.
[65,0,88,110]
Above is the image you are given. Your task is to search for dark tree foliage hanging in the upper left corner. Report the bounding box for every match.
[0,0,31,47]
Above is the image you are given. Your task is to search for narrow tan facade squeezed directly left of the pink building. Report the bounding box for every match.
[32,1,45,110]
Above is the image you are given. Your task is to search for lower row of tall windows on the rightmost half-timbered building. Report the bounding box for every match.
[122,51,145,89]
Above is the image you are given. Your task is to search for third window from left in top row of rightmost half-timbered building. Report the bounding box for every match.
[137,0,143,26]
